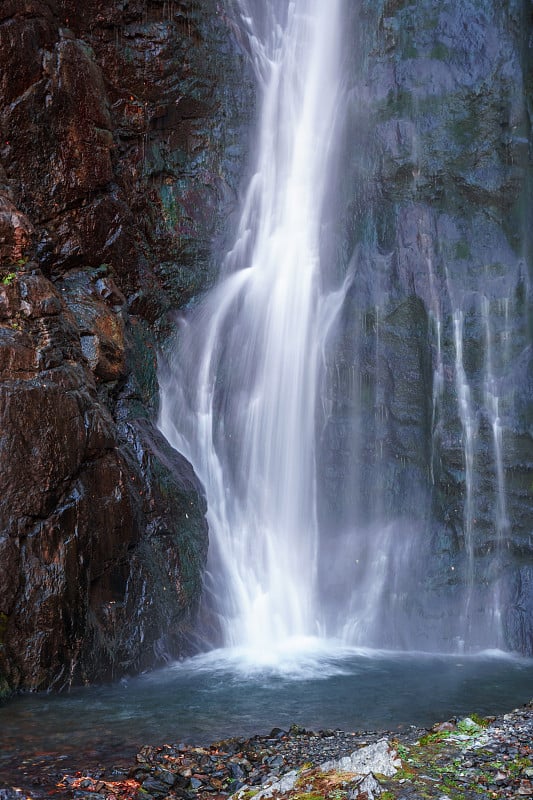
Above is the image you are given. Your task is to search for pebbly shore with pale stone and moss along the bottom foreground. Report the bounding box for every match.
[0,701,533,800]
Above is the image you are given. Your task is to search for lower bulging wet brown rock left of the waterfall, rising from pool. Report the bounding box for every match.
[0,274,207,689]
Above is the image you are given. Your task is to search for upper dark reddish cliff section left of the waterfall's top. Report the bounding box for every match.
[0,0,253,294]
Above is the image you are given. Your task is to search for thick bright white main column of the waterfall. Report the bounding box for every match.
[160,0,343,648]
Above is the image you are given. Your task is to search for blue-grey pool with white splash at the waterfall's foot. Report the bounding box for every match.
[0,639,533,782]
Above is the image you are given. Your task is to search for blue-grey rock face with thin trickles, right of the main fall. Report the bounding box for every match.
[321,0,533,653]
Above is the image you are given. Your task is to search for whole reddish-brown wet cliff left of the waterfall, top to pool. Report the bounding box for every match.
[0,0,251,692]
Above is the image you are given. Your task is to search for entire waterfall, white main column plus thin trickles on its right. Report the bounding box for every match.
[160,0,530,652]
